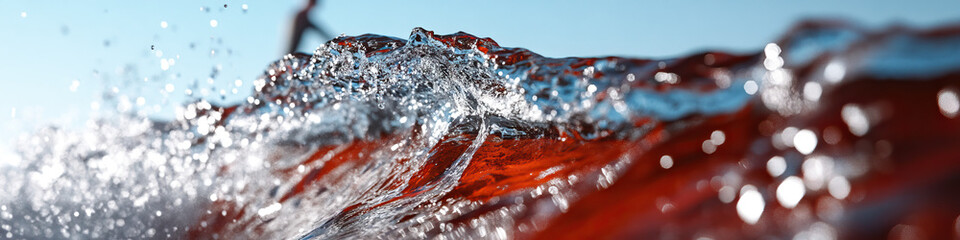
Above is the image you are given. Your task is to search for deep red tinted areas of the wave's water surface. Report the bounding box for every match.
[189,21,960,239]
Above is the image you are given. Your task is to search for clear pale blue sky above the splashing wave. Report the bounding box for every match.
[0,0,960,148]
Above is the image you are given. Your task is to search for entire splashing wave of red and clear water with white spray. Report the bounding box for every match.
[0,20,960,239]
